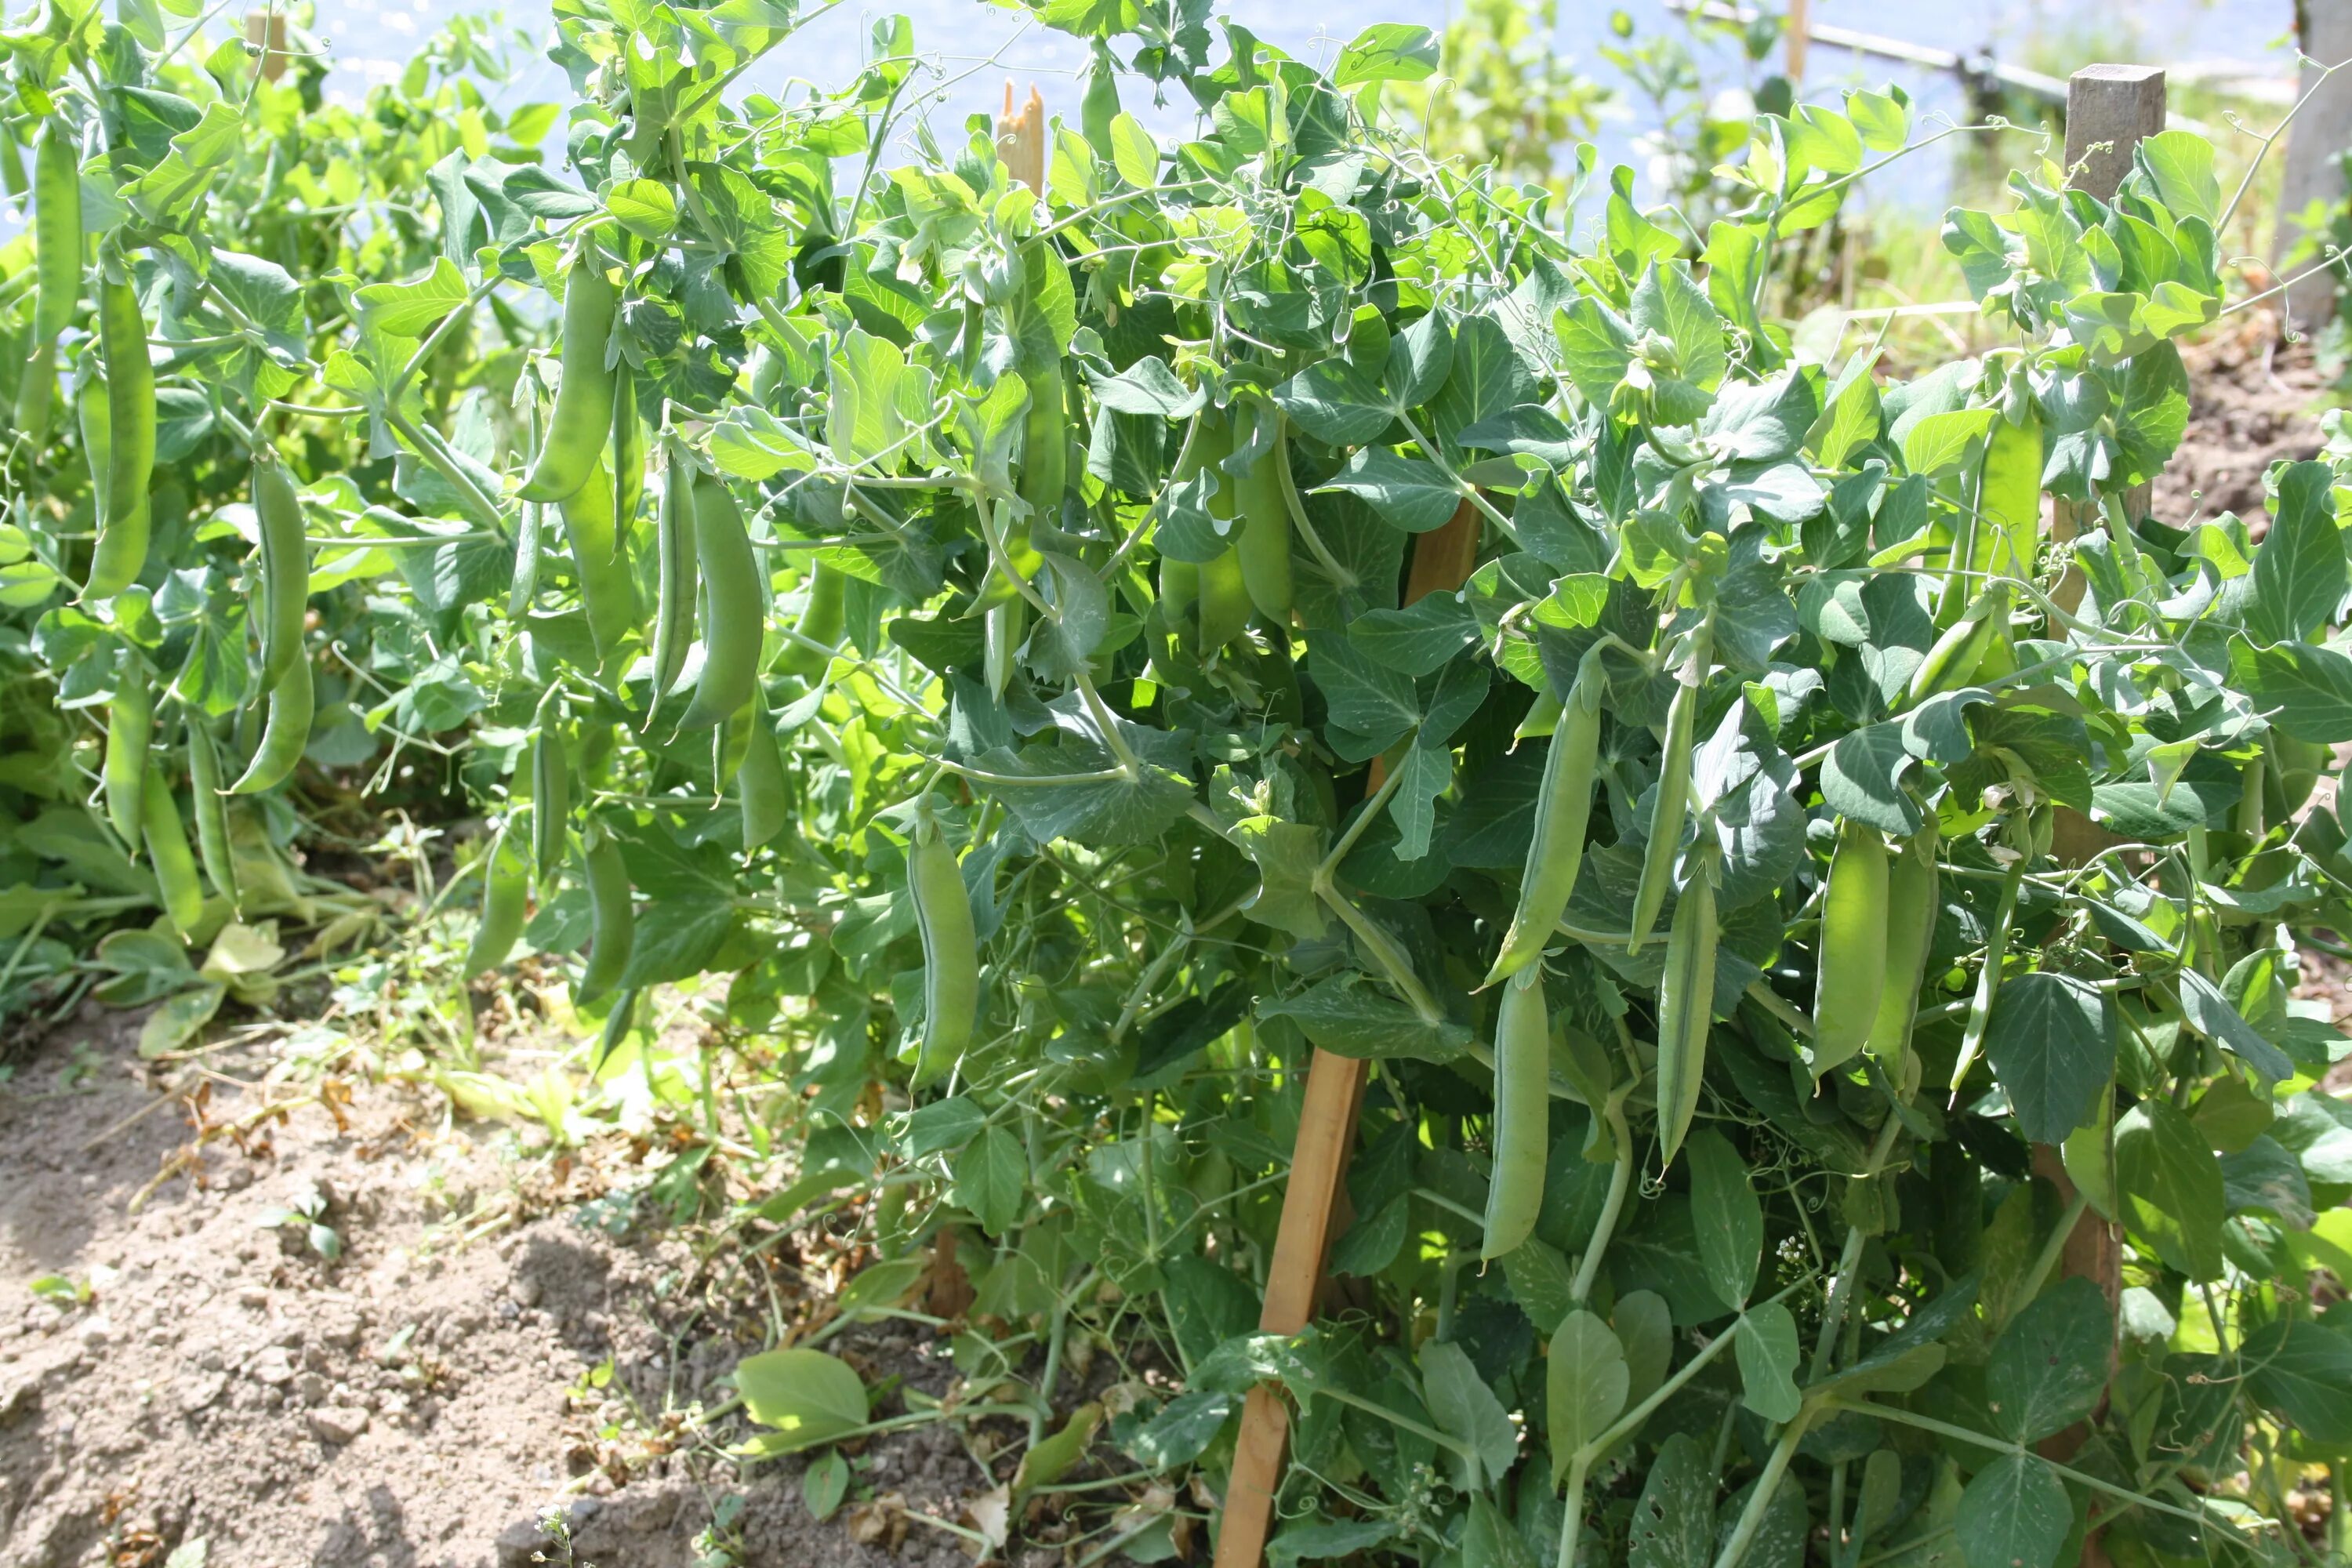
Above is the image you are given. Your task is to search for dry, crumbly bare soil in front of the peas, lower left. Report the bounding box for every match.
[0,1011,993,1568]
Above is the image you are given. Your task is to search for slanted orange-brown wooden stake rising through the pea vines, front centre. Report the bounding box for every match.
[1216,501,1482,1568]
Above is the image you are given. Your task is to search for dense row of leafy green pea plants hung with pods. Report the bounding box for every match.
[9,0,2352,1568]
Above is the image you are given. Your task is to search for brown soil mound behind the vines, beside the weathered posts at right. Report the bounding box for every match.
[2154,310,2328,536]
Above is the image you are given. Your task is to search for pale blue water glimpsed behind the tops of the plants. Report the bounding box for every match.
[303,0,2293,212]
